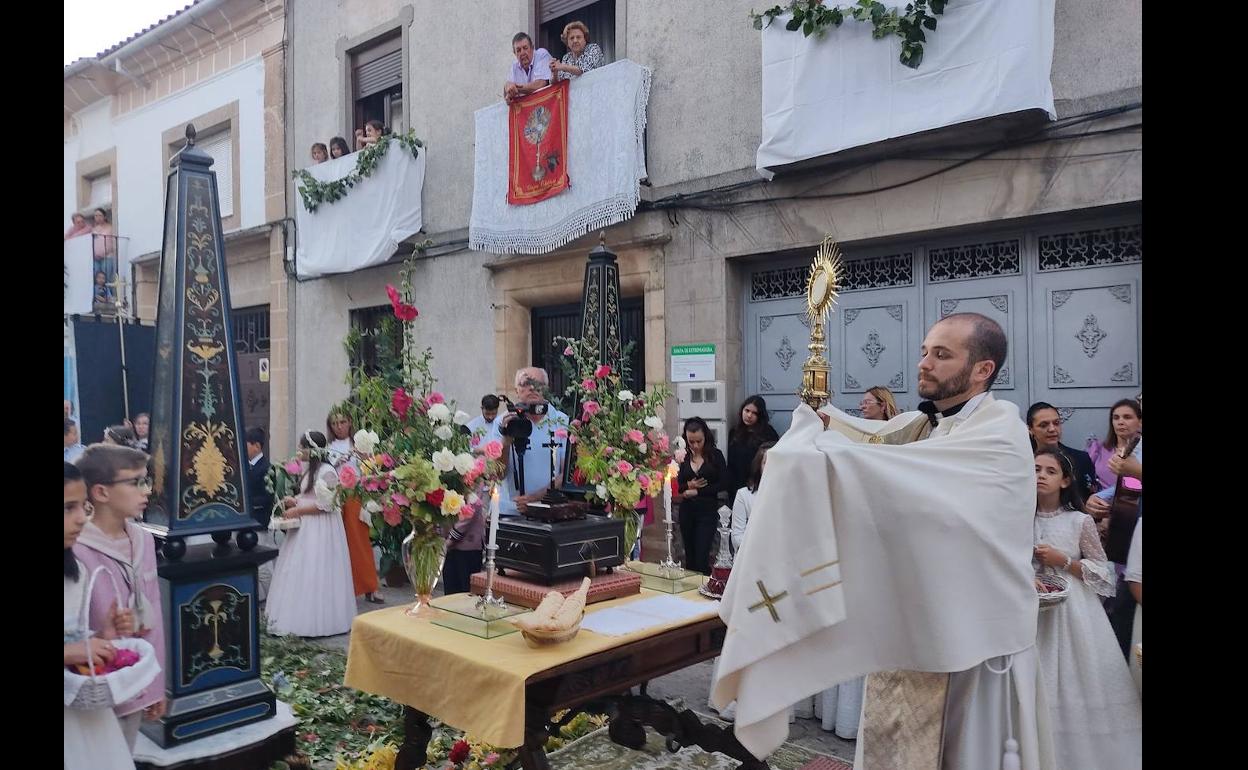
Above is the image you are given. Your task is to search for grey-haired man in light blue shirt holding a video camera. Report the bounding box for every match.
[487,367,568,515]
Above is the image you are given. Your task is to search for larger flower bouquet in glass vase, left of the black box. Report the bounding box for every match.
[337,255,502,609]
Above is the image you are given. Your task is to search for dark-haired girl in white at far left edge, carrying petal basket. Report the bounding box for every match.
[64,463,135,770]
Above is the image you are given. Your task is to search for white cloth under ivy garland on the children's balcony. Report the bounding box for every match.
[295,139,427,278]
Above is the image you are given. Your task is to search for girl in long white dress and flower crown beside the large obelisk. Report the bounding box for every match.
[265,431,356,636]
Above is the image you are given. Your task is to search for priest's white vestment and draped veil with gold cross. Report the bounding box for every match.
[713,394,1051,769]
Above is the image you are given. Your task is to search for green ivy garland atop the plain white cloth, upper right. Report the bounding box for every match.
[750,0,948,69]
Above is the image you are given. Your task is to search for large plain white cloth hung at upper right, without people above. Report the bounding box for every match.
[755,0,1057,178]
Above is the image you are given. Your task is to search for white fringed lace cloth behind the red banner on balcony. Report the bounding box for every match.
[468,59,650,255]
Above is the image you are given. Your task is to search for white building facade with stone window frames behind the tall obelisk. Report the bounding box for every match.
[64,0,291,454]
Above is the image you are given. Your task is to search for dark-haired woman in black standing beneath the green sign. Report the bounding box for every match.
[676,417,728,575]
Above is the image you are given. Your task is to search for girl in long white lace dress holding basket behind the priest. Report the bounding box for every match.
[1032,448,1143,770]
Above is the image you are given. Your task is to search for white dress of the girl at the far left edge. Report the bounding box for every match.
[65,562,135,770]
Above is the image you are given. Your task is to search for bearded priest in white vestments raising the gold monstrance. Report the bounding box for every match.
[711,313,1053,770]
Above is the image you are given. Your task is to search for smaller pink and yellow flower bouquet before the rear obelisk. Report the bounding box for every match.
[555,337,671,545]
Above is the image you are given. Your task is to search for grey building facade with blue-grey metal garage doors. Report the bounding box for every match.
[287,0,1142,446]
